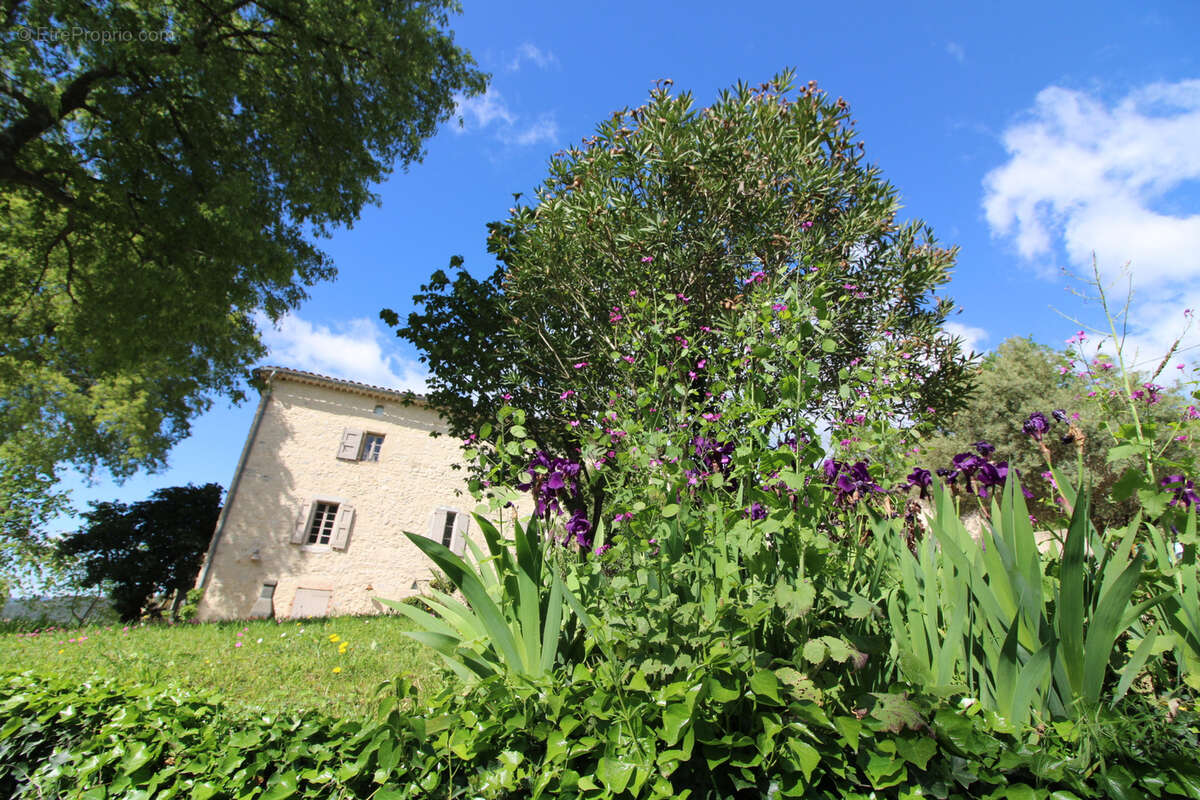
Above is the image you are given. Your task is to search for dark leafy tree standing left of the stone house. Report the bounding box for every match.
[56,483,222,620]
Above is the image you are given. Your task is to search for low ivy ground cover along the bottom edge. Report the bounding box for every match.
[9,671,1200,800]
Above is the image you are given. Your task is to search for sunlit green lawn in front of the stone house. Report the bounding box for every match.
[0,616,452,717]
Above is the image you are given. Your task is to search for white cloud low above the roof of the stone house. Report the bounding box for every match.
[258,314,425,392]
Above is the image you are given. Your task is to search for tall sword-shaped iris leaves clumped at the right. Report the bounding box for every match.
[889,479,1162,728]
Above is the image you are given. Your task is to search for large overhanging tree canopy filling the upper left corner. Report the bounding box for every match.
[0,0,485,534]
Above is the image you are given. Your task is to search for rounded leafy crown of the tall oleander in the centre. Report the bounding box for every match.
[393,73,970,462]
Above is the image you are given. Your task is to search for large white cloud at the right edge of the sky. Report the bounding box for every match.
[983,79,1200,361]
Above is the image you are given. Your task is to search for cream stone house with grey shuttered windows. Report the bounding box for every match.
[197,367,479,620]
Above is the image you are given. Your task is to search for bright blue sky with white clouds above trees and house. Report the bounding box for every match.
[55,0,1200,529]
